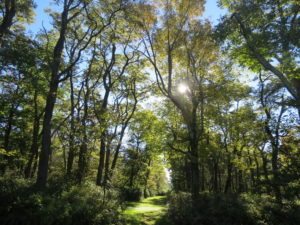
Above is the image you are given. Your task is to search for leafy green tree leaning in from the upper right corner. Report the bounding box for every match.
[218,0,300,116]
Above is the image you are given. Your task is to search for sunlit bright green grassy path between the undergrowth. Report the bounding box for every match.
[124,196,169,225]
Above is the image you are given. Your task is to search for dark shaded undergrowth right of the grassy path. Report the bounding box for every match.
[168,192,300,225]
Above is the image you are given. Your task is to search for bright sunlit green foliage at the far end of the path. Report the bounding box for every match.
[118,110,168,201]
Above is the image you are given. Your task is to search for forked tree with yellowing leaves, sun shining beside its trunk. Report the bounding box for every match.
[140,0,203,200]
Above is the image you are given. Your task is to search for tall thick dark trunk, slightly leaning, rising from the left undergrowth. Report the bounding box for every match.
[36,0,105,187]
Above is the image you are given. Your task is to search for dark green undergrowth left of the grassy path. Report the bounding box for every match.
[0,179,121,225]
